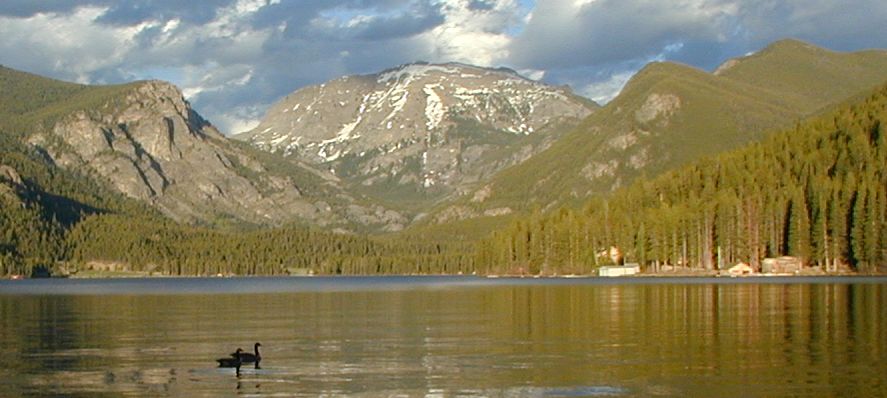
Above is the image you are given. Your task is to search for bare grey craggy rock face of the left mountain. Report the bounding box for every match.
[31,81,402,229]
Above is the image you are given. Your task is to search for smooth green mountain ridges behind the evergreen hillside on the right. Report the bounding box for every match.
[431,40,887,222]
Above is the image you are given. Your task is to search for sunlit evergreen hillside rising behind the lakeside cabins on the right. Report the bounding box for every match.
[477,86,887,274]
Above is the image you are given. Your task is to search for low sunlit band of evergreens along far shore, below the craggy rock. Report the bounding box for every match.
[67,215,471,275]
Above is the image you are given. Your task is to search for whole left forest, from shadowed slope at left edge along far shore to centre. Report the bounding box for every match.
[0,127,473,275]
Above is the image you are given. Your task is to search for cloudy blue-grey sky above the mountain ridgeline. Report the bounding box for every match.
[0,0,887,134]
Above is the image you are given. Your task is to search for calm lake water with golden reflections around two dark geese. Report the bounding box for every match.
[0,277,887,397]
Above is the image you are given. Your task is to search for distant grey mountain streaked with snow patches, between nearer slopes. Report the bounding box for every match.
[236,63,597,210]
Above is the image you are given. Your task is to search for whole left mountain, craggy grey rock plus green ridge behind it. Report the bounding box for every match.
[0,68,403,229]
